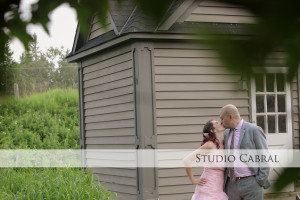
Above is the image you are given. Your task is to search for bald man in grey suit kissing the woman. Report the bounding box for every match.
[220,104,270,200]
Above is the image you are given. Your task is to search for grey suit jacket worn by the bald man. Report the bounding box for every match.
[224,121,270,189]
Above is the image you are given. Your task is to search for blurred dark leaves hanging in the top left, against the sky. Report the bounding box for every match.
[0,0,172,60]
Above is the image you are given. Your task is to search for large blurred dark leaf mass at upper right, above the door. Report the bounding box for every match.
[199,0,300,81]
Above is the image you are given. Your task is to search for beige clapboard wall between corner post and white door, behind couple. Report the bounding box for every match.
[154,44,250,200]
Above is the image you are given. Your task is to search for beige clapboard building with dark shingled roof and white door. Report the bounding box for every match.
[67,0,300,200]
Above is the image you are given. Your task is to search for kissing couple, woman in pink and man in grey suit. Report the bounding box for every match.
[184,104,270,200]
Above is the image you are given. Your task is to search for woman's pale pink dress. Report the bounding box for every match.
[192,155,228,200]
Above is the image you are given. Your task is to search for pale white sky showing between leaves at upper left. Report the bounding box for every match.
[10,0,77,61]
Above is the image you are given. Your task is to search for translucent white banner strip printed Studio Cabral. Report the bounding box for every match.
[0,149,300,168]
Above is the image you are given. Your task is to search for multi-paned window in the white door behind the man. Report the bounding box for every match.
[252,73,290,134]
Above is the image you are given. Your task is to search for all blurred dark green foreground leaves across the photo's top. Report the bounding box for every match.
[0,0,300,80]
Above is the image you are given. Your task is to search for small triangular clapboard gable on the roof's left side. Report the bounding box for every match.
[89,16,113,40]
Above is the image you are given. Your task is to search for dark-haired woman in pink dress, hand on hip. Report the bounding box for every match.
[184,120,228,200]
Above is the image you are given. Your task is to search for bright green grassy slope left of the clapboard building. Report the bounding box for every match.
[0,90,115,200]
